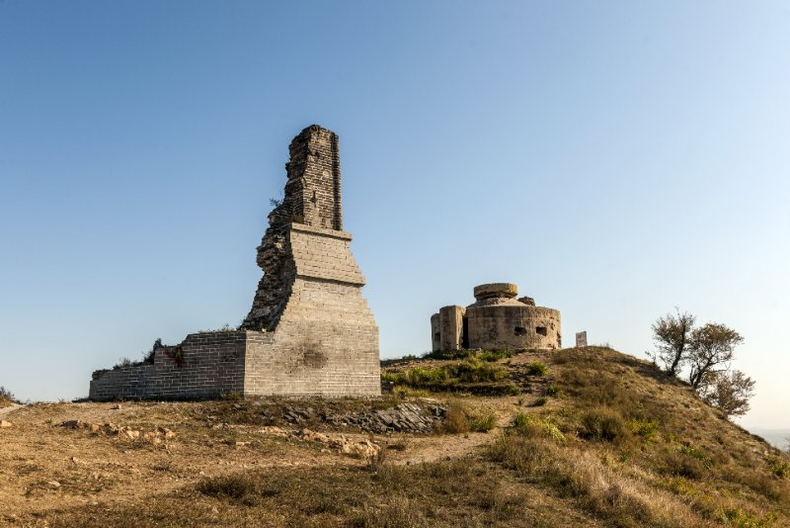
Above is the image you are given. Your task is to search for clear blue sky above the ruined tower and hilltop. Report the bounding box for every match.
[0,0,790,427]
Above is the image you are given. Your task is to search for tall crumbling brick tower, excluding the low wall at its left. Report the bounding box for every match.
[242,125,380,394]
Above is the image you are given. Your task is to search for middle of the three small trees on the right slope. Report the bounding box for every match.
[688,323,743,391]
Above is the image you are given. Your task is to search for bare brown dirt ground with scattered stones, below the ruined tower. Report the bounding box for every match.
[0,402,504,523]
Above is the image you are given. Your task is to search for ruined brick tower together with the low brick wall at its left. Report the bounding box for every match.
[90,125,381,400]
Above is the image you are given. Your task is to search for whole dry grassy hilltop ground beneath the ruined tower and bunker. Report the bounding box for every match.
[0,347,790,527]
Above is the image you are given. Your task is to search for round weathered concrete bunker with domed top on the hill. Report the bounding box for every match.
[431,283,562,351]
